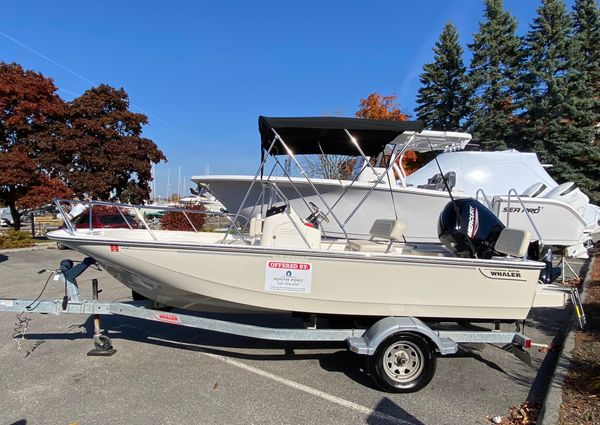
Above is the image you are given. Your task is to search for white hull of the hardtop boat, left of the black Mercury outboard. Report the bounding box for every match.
[193,175,466,243]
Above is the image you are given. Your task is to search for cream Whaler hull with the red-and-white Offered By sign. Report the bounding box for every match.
[49,229,543,320]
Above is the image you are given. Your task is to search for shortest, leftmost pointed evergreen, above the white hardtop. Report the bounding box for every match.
[415,23,467,130]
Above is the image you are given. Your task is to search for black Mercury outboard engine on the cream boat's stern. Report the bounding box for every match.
[438,198,505,259]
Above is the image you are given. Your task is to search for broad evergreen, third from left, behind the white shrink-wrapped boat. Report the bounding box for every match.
[519,0,600,201]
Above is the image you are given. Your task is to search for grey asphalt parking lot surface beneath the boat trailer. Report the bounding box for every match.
[0,249,580,424]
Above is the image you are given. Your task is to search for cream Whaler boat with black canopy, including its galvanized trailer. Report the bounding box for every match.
[0,118,580,392]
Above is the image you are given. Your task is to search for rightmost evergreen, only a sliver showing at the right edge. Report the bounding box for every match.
[573,0,600,132]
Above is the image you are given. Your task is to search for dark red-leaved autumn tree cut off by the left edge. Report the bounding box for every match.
[0,62,71,229]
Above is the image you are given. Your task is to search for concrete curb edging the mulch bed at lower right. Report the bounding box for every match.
[537,258,596,425]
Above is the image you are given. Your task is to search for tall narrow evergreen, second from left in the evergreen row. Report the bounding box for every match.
[467,0,521,150]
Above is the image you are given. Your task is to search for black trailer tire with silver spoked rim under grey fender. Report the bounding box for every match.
[367,333,437,393]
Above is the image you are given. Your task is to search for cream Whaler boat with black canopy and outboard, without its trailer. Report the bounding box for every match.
[48,117,565,320]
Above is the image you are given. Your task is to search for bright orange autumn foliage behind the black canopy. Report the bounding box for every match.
[356,93,422,175]
